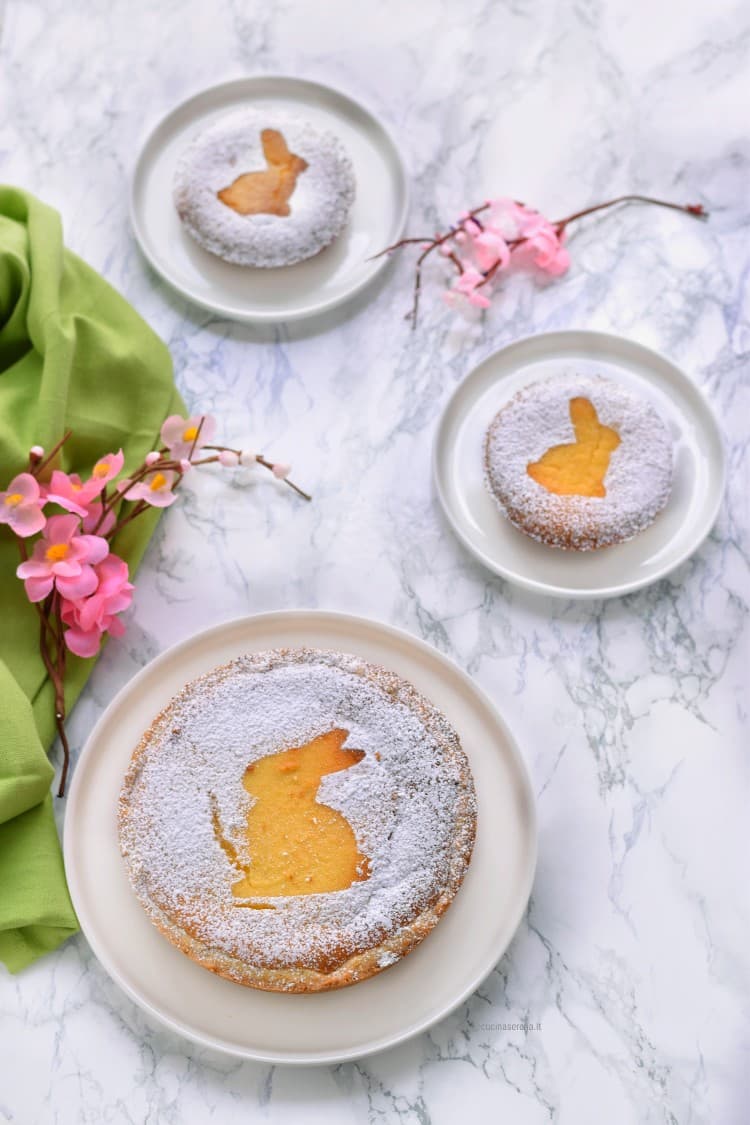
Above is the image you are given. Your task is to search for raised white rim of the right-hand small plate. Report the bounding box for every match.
[432,329,726,601]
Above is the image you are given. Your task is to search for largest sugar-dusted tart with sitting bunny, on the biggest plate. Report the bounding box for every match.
[119,648,477,992]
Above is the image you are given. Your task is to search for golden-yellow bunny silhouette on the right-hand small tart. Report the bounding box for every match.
[526,398,620,496]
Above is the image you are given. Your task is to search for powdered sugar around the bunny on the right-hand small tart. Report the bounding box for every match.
[485,374,672,550]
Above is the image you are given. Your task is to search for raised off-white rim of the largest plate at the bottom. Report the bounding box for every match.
[63,609,539,1067]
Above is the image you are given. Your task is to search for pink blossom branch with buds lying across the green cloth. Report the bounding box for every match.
[0,414,311,797]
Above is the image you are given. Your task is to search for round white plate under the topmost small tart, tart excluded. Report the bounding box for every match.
[130,77,408,322]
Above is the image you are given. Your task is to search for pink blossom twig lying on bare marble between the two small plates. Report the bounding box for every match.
[374,195,708,329]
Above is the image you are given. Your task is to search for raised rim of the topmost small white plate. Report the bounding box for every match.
[128,73,410,324]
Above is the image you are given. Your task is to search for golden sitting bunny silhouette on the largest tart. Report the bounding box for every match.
[214,729,370,899]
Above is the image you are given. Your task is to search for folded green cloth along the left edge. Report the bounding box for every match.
[0,187,183,972]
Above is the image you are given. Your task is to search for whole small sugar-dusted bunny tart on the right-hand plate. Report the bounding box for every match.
[485,375,672,551]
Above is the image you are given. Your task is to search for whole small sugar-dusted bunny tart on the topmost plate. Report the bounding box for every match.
[173,109,354,267]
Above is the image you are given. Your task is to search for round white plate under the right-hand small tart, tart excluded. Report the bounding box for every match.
[433,332,725,597]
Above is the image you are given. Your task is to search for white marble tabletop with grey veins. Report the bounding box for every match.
[0,0,750,1125]
